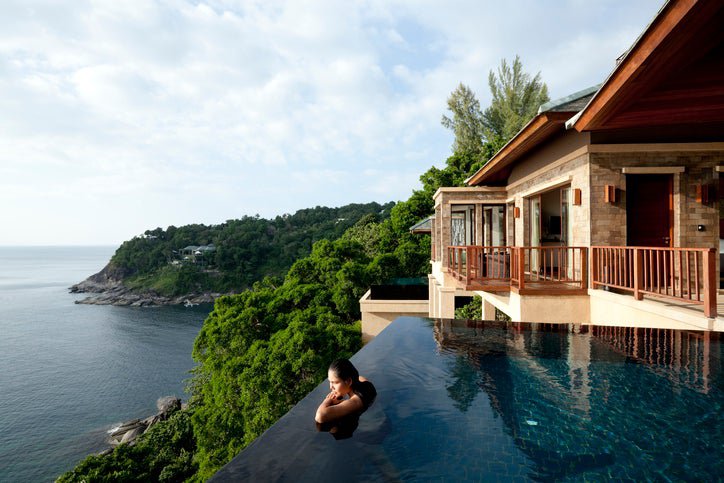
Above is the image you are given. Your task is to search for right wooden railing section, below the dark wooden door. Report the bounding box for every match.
[591,246,717,317]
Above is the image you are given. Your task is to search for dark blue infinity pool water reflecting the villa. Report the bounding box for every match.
[215,317,724,481]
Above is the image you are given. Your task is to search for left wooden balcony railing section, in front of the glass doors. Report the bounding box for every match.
[447,246,588,291]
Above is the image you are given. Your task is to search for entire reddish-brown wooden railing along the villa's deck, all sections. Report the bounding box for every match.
[447,246,717,317]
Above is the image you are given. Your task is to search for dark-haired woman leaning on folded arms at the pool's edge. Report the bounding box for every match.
[314,359,377,423]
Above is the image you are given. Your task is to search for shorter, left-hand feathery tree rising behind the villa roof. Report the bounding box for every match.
[441,82,484,154]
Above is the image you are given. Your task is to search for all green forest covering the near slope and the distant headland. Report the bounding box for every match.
[60,55,542,482]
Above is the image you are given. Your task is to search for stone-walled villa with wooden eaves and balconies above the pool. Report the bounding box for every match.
[361,1,724,338]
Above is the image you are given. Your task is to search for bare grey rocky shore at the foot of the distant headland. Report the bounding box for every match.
[70,264,222,307]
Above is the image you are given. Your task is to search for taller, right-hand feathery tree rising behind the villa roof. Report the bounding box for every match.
[482,55,550,152]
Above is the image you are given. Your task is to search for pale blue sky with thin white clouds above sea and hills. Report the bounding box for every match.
[0,0,663,245]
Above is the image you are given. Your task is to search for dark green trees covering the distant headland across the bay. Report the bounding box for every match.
[110,203,393,295]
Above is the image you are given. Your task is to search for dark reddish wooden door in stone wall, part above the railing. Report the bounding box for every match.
[626,174,674,247]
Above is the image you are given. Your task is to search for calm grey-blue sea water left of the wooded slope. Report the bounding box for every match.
[0,247,210,482]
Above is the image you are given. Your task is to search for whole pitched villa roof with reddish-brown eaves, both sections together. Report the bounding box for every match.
[466,0,724,186]
